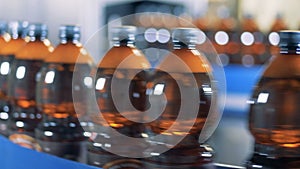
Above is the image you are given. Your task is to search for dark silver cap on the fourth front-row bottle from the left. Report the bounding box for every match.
[59,25,80,41]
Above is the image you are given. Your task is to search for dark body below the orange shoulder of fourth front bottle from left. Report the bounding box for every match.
[35,60,91,162]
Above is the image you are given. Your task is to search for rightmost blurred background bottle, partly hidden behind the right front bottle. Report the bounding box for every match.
[267,14,287,59]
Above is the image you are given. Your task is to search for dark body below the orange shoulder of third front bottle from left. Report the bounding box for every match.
[8,59,43,151]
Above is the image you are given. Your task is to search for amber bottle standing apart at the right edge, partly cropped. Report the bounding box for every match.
[247,30,300,169]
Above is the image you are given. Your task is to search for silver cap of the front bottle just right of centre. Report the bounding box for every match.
[172,28,200,45]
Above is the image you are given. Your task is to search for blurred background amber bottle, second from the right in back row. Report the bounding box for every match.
[240,14,267,67]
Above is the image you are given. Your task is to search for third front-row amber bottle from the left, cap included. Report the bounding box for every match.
[8,24,53,151]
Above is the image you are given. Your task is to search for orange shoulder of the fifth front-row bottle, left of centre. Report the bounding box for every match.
[98,46,151,69]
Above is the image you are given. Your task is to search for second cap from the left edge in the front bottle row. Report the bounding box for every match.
[8,21,29,39]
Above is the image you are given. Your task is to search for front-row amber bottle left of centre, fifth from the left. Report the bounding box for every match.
[88,26,150,169]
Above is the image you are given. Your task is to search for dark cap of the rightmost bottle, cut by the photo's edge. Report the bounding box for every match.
[279,30,300,47]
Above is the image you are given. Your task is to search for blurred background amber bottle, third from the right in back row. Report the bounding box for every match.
[211,6,240,66]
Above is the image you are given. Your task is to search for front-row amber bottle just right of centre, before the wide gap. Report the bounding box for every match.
[144,28,216,169]
